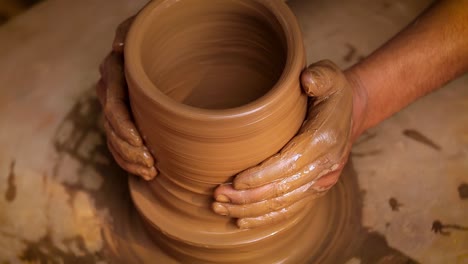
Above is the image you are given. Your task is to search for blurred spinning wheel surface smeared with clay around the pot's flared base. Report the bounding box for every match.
[105,166,360,263]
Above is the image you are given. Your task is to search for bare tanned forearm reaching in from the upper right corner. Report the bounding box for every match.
[346,0,468,137]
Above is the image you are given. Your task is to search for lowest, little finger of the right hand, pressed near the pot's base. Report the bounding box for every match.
[237,196,312,229]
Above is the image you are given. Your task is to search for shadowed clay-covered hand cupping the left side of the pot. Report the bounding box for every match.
[96,17,157,180]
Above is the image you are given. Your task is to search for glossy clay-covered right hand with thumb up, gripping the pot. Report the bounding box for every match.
[213,61,353,228]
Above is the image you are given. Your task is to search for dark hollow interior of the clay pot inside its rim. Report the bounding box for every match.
[138,1,286,109]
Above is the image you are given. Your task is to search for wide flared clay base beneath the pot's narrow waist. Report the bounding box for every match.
[130,177,313,263]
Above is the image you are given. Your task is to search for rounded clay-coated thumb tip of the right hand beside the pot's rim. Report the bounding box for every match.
[301,60,346,97]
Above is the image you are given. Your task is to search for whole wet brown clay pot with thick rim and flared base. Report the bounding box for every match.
[125,0,313,263]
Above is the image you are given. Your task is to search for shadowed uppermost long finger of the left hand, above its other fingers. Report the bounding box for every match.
[102,53,143,147]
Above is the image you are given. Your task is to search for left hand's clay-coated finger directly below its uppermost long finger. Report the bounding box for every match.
[104,119,154,168]
